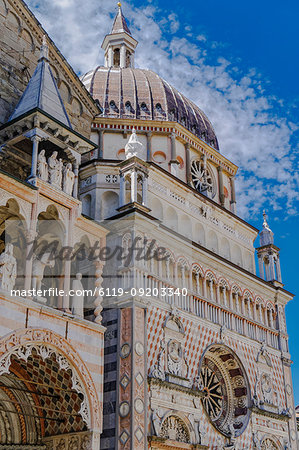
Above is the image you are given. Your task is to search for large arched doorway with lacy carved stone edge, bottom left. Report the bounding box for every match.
[0,329,100,449]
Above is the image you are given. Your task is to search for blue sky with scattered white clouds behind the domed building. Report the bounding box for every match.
[27,0,299,404]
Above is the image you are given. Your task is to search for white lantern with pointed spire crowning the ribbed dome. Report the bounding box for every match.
[102,3,138,69]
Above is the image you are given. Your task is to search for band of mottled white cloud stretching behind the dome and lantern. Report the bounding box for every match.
[28,0,299,218]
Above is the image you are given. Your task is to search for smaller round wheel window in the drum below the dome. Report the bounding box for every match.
[191,159,216,198]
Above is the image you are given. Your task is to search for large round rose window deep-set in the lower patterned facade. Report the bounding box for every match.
[200,345,250,437]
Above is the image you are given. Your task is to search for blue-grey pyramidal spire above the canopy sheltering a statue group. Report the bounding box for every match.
[9,36,72,128]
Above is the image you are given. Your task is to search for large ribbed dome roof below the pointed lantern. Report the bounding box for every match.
[81,66,219,150]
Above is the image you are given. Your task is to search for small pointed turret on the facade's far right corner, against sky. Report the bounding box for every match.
[257,211,282,283]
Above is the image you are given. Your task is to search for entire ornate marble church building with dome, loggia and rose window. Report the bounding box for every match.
[0,0,298,450]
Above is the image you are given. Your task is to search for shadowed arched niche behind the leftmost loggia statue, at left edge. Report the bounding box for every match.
[0,198,27,289]
